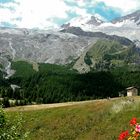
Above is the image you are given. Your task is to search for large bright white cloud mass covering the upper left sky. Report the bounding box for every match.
[0,0,70,28]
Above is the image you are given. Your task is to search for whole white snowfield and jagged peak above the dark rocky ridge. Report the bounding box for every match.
[61,10,140,43]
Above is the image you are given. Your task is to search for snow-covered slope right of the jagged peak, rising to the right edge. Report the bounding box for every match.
[92,11,140,44]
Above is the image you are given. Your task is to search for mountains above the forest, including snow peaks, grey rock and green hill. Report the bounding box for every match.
[0,11,140,78]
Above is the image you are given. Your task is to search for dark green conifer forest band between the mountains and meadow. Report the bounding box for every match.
[0,61,140,107]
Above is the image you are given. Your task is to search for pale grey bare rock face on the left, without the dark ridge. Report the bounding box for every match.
[0,29,91,64]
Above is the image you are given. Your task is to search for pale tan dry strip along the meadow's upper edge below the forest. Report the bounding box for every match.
[5,99,106,111]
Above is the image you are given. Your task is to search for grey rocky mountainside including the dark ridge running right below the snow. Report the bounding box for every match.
[0,27,134,79]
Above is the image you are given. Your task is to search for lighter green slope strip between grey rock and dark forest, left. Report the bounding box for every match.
[12,61,75,78]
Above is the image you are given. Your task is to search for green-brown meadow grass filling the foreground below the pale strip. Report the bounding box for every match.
[8,97,140,140]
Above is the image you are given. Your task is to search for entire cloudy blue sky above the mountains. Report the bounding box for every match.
[0,0,140,29]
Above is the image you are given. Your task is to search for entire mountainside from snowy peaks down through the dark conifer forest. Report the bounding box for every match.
[0,11,140,104]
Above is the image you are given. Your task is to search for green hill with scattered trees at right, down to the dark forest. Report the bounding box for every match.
[74,39,140,72]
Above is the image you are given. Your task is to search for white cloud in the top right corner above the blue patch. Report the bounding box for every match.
[92,0,140,14]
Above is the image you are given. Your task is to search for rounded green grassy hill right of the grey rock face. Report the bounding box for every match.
[85,40,140,70]
